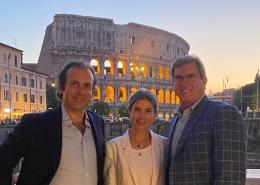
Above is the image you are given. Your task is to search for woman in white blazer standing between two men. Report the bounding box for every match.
[104,89,166,185]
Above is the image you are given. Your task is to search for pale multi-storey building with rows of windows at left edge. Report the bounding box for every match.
[0,43,47,120]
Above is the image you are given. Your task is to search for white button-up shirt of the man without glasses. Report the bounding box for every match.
[50,106,98,185]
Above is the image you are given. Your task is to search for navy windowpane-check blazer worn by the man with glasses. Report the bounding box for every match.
[166,96,247,185]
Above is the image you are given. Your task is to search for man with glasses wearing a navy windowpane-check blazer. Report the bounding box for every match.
[166,55,247,185]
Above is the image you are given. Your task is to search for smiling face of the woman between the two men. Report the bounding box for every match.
[129,99,155,131]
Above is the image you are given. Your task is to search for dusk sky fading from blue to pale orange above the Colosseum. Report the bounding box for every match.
[0,0,260,93]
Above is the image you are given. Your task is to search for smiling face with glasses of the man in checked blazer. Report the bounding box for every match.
[173,63,207,109]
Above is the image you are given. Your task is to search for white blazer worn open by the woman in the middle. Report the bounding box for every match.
[104,130,167,185]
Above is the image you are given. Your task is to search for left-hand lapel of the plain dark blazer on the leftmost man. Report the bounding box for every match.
[44,107,62,173]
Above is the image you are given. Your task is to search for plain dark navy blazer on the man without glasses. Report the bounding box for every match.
[0,107,105,185]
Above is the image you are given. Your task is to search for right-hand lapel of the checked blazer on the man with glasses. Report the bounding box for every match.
[176,96,208,154]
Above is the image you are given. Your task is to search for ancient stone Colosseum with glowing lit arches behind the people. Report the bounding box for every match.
[36,14,190,119]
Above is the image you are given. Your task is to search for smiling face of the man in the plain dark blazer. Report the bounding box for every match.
[60,67,93,112]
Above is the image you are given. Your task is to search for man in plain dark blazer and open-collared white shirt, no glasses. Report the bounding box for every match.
[0,62,105,185]
